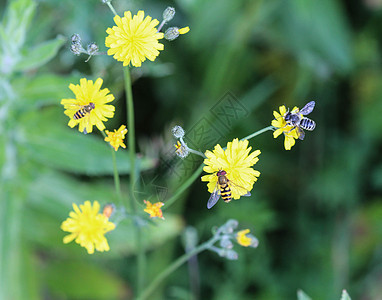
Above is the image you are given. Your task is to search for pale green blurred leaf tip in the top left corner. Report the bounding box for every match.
[2,0,37,49]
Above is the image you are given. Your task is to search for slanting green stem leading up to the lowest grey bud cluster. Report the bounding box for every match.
[137,235,220,300]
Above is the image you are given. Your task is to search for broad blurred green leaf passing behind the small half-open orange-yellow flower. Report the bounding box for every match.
[22,107,155,175]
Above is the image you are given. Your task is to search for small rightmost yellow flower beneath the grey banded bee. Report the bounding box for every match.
[272,105,298,150]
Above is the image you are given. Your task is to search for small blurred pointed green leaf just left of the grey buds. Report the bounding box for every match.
[15,36,65,71]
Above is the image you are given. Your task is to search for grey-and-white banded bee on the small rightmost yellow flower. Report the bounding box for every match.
[283,101,316,140]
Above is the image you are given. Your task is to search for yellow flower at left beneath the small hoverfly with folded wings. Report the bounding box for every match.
[61,78,115,133]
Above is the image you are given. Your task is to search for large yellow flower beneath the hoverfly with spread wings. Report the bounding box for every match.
[201,139,261,199]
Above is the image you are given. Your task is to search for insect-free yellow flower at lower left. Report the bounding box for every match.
[61,201,115,254]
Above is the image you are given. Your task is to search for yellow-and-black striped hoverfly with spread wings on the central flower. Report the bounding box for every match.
[207,170,251,209]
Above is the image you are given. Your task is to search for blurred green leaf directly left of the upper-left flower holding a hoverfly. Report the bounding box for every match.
[12,74,81,108]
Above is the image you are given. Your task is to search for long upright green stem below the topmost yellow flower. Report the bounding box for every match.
[123,67,146,295]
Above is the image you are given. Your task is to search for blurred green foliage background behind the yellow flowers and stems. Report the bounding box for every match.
[0,0,382,300]
